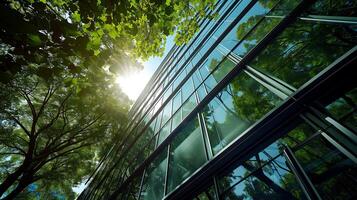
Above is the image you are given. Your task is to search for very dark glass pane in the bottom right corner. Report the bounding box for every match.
[294,136,357,199]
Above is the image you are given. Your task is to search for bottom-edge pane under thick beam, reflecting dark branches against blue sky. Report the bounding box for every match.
[222,156,306,200]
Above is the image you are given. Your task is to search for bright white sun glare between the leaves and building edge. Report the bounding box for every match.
[116,69,150,100]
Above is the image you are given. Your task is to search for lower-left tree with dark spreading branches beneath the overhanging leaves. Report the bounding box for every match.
[0,67,128,199]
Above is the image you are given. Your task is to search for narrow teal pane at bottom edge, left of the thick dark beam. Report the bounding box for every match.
[140,149,167,200]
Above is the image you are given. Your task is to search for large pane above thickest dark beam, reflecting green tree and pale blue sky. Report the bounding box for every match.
[203,73,281,154]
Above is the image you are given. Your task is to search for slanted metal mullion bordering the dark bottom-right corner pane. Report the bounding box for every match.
[283,146,321,200]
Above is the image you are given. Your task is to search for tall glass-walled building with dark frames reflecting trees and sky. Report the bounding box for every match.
[78,0,357,200]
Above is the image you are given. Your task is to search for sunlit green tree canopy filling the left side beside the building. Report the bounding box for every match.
[0,0,214,199]
